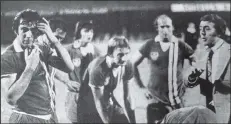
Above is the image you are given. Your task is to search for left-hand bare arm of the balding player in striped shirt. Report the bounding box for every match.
[132,51,145,88]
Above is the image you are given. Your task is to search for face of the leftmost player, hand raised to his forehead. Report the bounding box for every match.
[17,19,38,48]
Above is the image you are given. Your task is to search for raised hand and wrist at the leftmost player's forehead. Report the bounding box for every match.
[37,18,59,44]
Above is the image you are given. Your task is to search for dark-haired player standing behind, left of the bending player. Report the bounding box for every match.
[55,21,100,123]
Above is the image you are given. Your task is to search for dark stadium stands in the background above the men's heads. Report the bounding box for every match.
[1,1,230,44]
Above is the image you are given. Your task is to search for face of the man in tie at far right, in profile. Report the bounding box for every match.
[200,21,217,46]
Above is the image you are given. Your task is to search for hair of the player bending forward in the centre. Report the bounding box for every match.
[107,36,130,55]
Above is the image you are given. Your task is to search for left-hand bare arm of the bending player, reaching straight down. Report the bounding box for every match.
[90,86,109,123]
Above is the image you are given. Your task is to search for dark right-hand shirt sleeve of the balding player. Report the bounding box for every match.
[179,41,194,58]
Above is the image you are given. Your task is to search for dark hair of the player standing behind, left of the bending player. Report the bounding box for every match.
[74,20,94,40]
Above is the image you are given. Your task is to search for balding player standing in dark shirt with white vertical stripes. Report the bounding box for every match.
[133,14,193,122]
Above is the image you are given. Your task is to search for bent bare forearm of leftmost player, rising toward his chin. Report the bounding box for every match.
[1,49,40,105]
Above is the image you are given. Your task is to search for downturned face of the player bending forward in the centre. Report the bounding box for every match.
[113,47,130,65]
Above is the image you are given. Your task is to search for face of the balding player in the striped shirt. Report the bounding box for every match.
[157,17,173,39]
